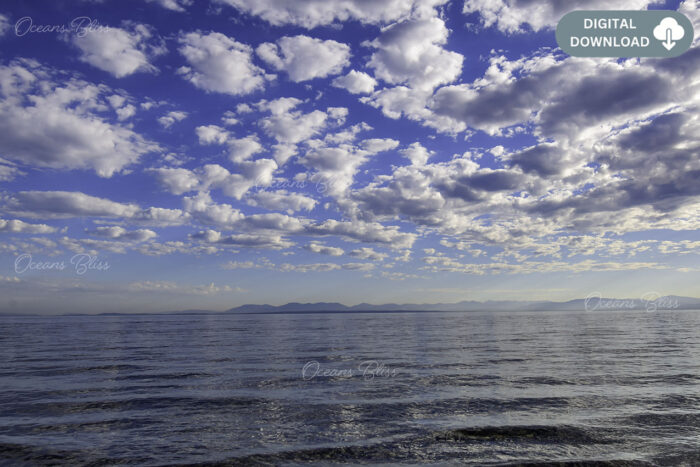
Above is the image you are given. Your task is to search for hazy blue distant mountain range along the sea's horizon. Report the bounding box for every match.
[227,294,700,313]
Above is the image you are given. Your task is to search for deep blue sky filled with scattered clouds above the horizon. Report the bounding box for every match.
[0,0,700,313]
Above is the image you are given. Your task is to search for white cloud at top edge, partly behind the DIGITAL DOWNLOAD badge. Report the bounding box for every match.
[463,0,660,34]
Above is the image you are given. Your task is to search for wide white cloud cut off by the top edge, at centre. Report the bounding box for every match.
[217,0,446,29]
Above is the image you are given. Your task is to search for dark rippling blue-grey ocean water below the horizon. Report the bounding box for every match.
[0,310,700,466]
